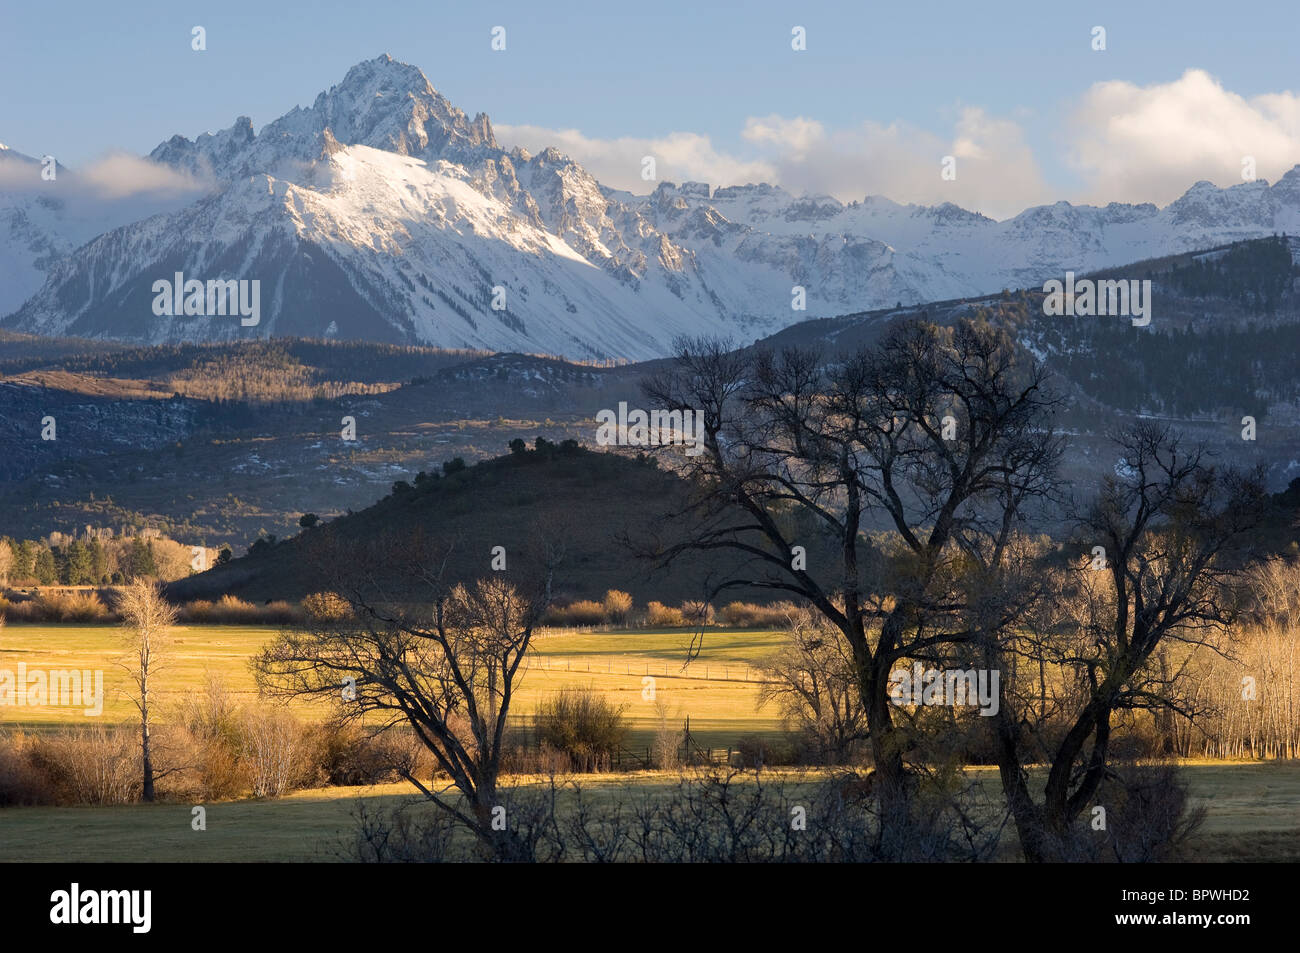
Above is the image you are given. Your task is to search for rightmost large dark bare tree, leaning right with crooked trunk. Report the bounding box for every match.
[984,423,1265,861]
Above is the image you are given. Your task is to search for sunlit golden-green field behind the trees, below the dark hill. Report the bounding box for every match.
[0,625,780,750]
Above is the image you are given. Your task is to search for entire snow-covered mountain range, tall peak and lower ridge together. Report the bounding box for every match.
[0,56,1300,358]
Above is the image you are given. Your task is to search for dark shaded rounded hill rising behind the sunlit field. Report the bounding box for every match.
[158,441,771,605]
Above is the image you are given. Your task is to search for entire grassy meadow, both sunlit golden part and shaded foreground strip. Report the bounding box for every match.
[0,624,1300,862]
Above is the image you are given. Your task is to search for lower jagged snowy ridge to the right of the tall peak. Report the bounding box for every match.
[633,166,1300,313]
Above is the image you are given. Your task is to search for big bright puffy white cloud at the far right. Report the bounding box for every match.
[1066,69,1300,205]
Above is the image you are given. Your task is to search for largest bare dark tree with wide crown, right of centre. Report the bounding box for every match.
[632,320,1060,816]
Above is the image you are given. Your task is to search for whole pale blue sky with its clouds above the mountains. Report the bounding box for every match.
[0,0,1300,218]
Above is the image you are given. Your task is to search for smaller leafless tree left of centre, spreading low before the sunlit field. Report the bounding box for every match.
[255,546,550,859]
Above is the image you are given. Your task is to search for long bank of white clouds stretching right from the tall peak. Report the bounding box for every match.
[498,69,1300,217]
